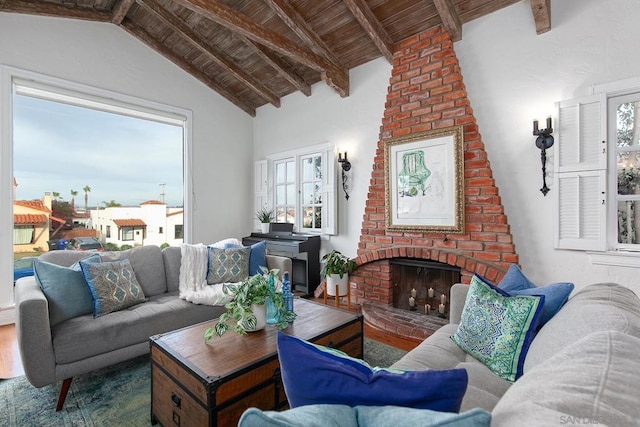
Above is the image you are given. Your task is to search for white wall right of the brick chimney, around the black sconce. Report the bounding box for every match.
[455,0,640,294]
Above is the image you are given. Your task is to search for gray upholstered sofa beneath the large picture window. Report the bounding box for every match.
[15,246,292,410]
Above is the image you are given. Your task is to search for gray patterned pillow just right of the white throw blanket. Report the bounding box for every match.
[207,246,251,285]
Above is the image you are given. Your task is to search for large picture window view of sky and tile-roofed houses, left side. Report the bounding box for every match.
[13,83,185,280]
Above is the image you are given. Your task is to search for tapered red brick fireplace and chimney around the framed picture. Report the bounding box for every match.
[351,27,518,335]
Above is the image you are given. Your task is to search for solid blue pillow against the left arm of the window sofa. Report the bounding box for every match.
[33,254,100,327]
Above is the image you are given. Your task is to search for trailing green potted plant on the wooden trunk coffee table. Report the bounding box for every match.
[204,267,296,343]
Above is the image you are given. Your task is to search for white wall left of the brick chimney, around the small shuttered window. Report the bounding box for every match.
[253,58,391,257]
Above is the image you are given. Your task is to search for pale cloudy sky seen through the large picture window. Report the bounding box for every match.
[13,95,183,209]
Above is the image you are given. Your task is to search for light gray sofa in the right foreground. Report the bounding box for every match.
[393,283,640,427]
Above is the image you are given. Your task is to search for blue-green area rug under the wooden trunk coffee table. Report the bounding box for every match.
[0,338,406,427]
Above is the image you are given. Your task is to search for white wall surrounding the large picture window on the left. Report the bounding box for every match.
[0,13,253,318]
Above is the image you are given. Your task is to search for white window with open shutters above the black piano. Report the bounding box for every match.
[255,144,337,234]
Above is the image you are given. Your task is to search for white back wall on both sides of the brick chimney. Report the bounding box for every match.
[254,0,640,294]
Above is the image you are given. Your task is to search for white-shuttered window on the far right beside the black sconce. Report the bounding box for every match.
[554,79,640,252]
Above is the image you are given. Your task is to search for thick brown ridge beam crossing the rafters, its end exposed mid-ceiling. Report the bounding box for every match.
[174,0,349,97]
